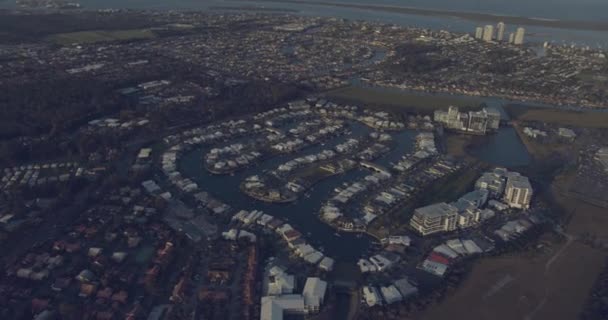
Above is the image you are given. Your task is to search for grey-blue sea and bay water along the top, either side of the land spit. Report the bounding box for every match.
[0,0,608,48]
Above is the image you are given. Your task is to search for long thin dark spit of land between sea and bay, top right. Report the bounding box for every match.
[238,0,608,31]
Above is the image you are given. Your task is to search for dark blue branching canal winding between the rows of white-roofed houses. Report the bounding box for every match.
[179,122,413,262]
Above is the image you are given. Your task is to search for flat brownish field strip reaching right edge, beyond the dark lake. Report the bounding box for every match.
[505,105,608,128]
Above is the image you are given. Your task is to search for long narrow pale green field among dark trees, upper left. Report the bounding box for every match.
[48,29,156,45]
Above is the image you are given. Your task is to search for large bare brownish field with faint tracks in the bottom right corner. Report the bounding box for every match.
[415,242,606,320]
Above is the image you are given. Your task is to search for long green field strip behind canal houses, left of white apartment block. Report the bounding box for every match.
[326,87,481,114]
